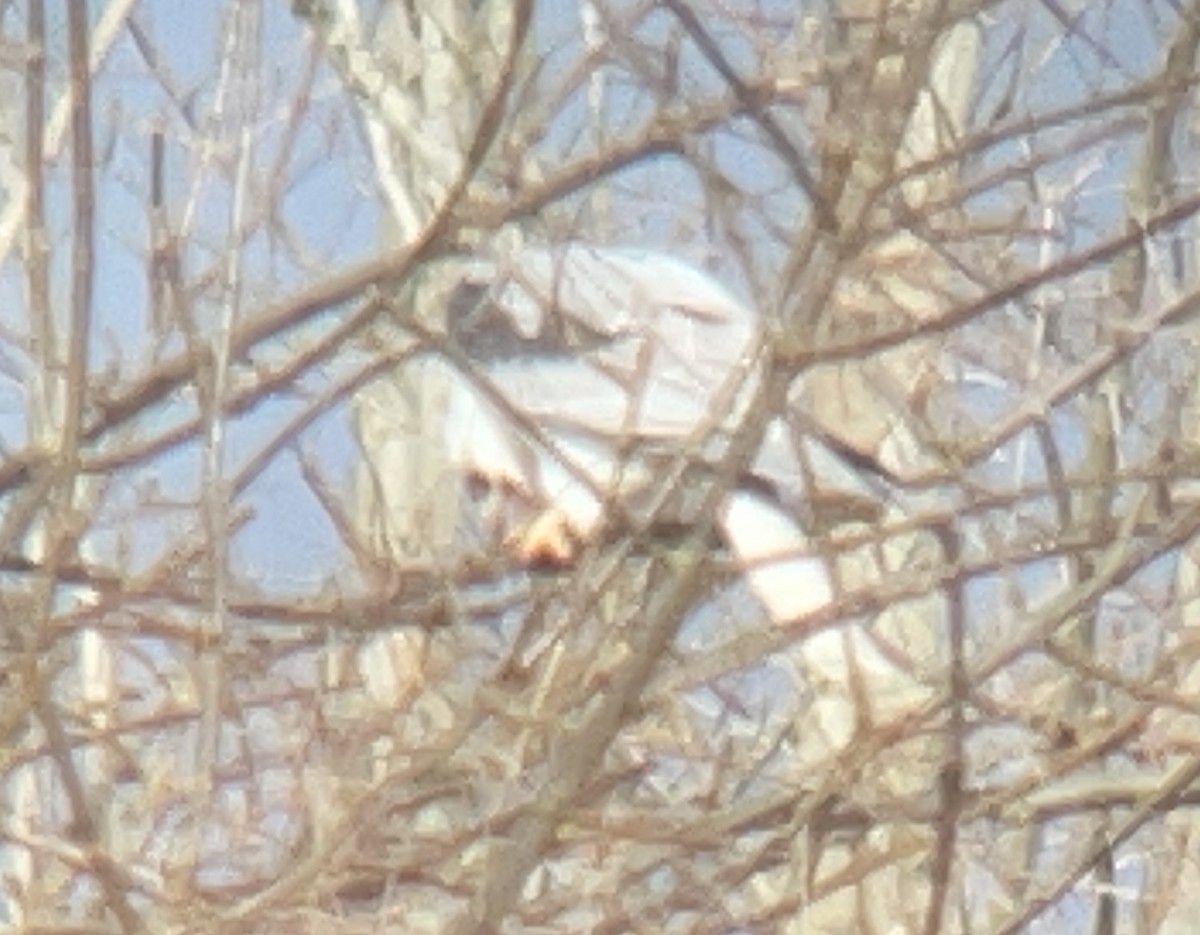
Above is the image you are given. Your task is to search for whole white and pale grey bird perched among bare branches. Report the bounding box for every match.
[443,241,833,622]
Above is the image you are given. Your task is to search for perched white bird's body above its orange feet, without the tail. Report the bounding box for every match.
[448,245,760,559]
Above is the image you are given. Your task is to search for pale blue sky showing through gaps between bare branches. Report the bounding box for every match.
[0,0,1166,926]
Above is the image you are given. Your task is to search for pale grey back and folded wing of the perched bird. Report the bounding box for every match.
[475,244,760,439]
